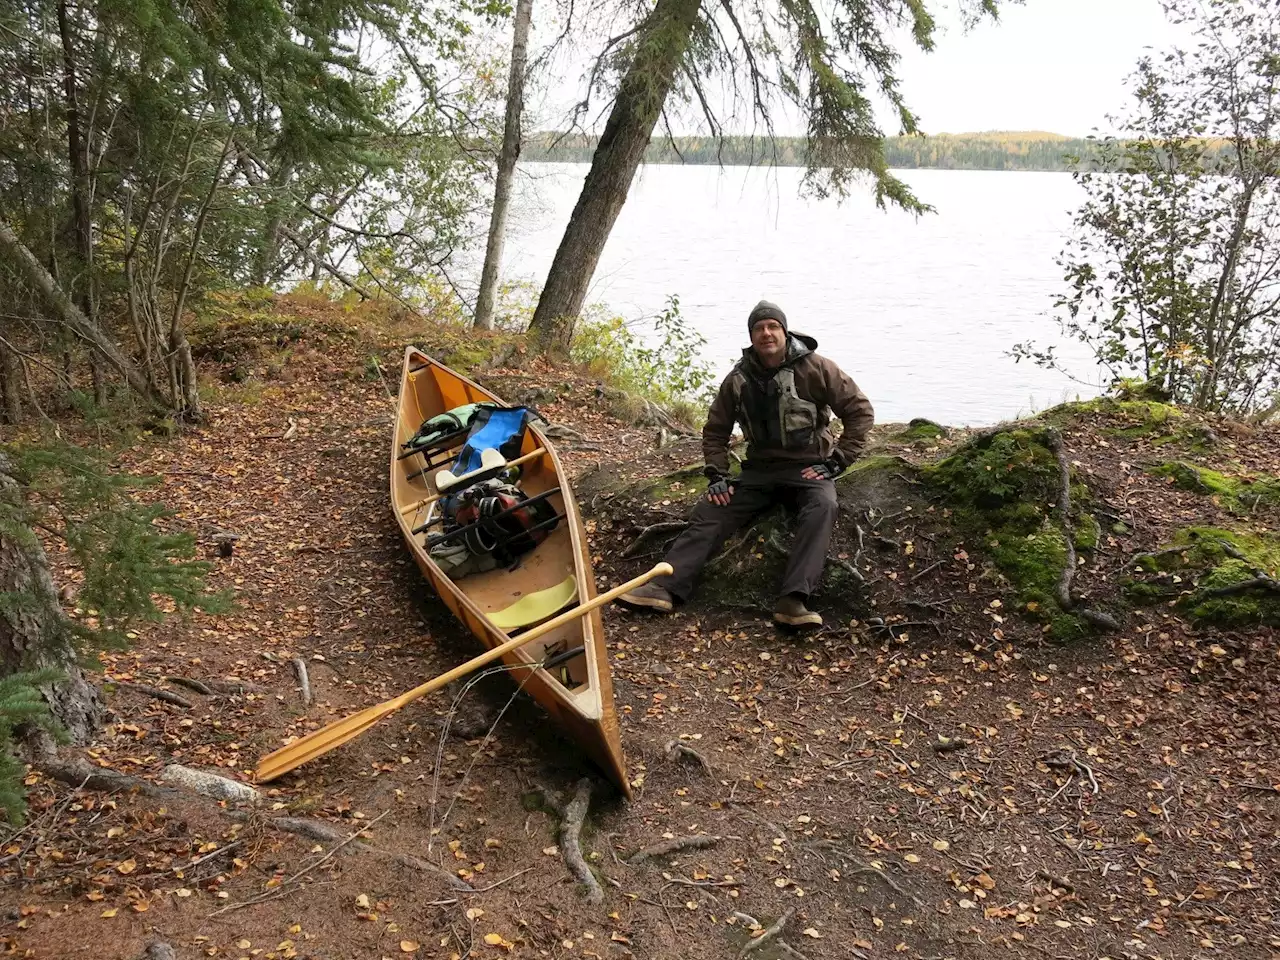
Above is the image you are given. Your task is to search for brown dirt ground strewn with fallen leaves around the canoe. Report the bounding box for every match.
[0,309,1280,960]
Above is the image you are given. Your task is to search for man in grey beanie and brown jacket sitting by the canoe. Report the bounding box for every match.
[618,300,874,627]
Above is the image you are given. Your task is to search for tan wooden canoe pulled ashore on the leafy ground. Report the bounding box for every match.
[390,347,631,797]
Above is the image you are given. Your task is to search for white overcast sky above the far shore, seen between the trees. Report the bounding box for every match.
[531,0,1176,136]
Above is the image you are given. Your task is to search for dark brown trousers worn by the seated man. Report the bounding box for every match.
[654,463,837,600]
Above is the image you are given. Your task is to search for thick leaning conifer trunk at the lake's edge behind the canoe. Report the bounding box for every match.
[529,0,701,353]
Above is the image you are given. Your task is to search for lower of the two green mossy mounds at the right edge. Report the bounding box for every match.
[1124,526,1280,626]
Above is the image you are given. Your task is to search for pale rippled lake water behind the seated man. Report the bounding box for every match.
[503,164,1098,425]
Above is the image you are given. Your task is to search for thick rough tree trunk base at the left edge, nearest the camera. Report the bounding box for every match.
[0,454,102,742]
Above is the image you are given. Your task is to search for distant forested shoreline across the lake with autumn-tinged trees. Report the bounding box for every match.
[521,131,1216,170]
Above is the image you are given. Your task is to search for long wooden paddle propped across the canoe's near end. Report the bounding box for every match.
[253,563,672,783]
